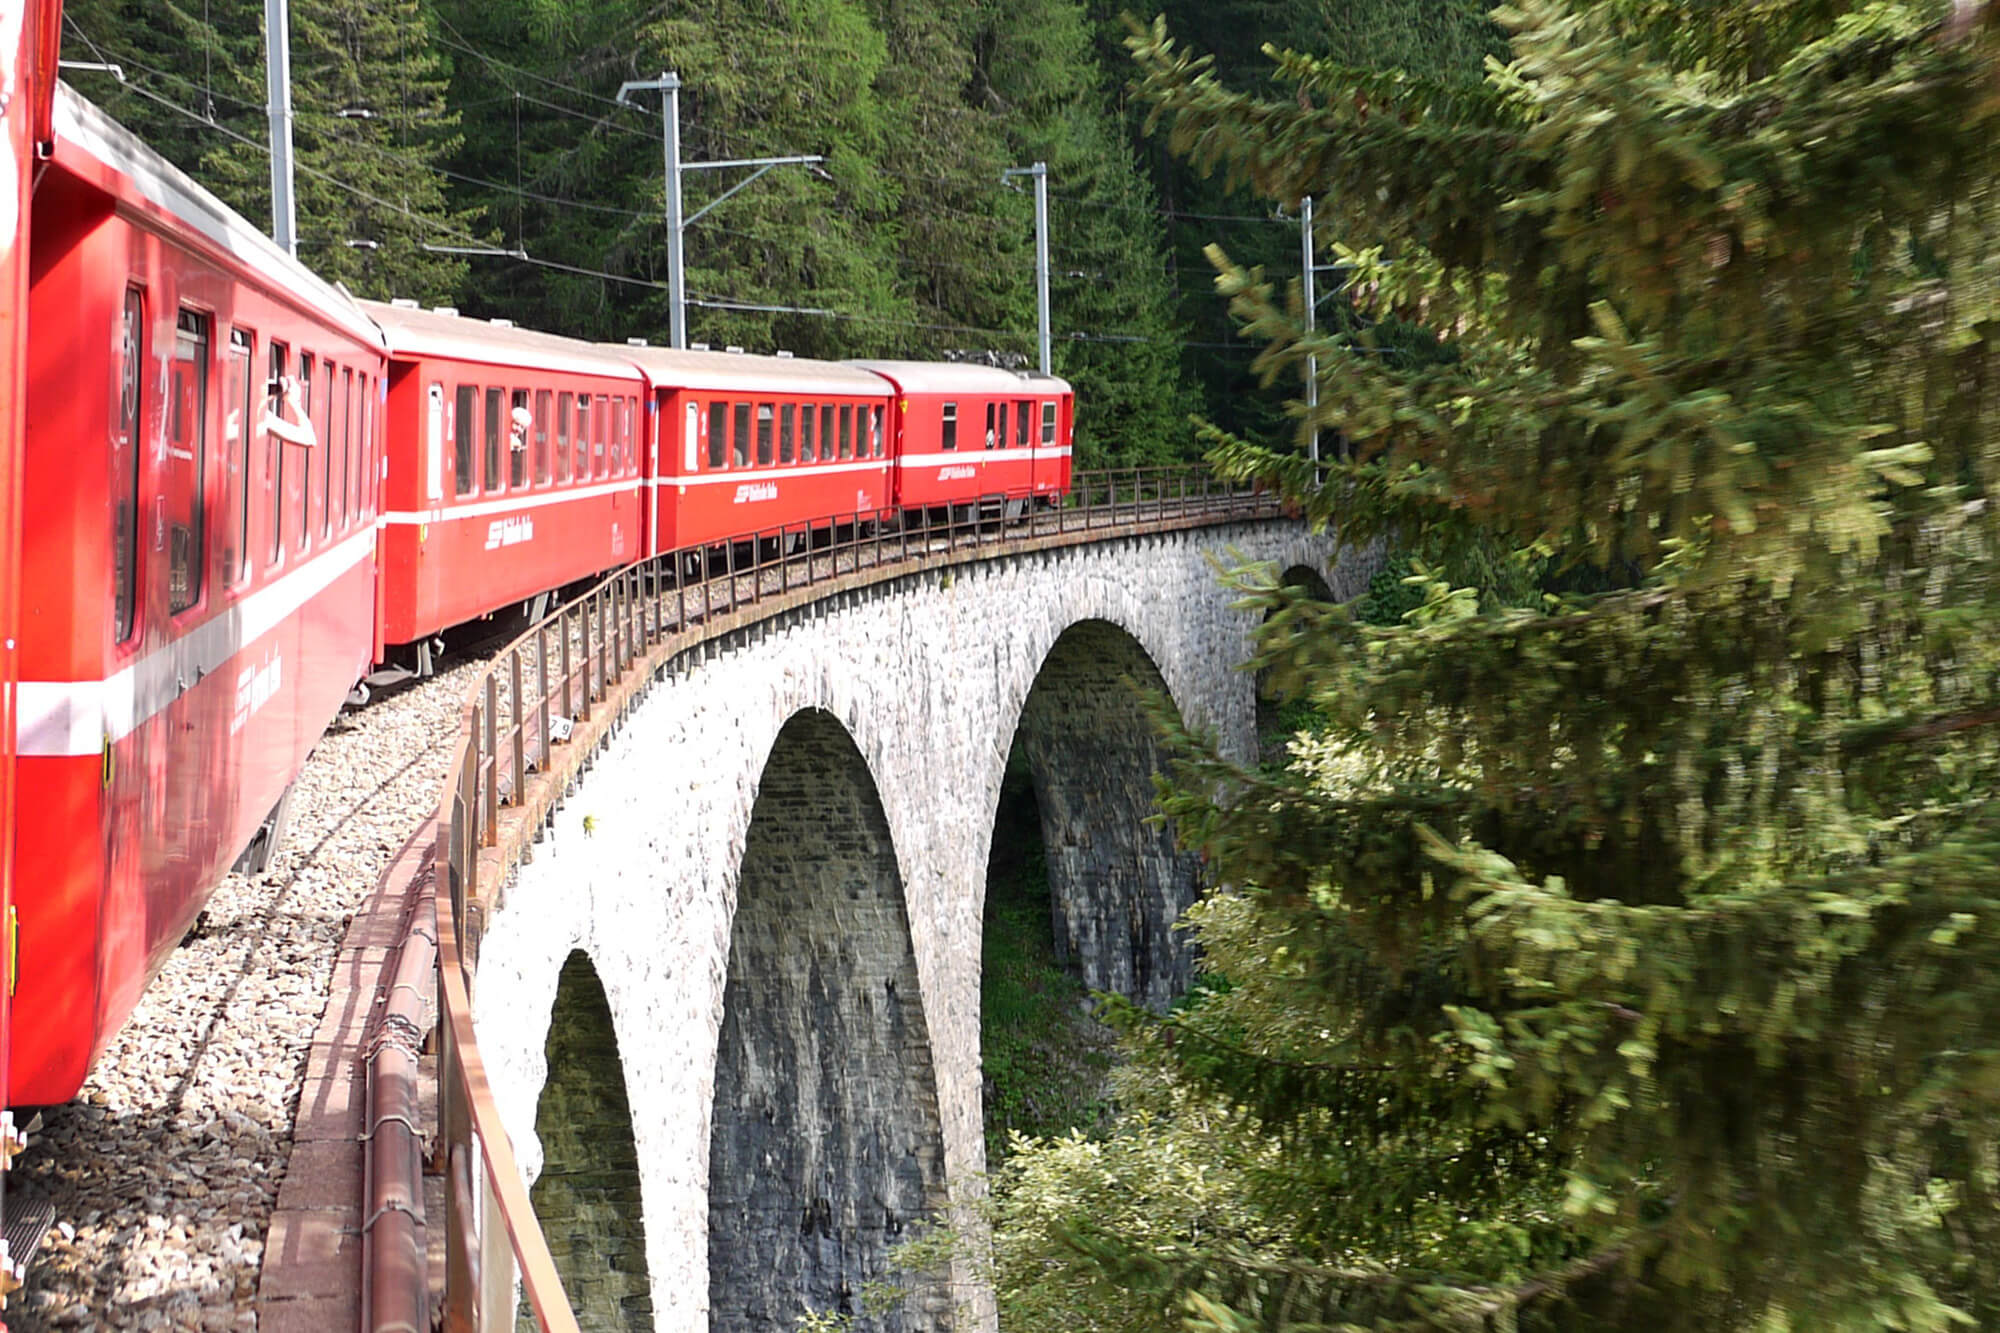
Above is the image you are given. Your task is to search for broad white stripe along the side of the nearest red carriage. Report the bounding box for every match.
[16,528,376,759]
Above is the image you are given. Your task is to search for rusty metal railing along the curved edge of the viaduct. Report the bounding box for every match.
[384,466,1284,1333]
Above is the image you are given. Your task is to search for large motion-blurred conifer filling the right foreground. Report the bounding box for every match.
[998,0,2000,1331]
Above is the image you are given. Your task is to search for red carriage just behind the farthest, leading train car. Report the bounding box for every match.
[630,348,892,554]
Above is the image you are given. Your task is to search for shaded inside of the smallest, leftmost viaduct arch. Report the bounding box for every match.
[528,949,652,1333]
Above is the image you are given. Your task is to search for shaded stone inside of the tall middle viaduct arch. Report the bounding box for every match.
[708,713,950,1333]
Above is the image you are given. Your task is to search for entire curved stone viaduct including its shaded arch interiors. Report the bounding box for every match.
[474,520,1370,1333]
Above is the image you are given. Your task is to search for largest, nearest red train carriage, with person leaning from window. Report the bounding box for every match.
[8,88,384,1105]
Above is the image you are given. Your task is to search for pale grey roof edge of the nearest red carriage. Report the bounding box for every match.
[54,84,382,346]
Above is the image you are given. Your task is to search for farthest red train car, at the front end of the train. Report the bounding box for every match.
[850,360,1074,516]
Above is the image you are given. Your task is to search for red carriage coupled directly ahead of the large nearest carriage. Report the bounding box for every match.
[362,302,650,675]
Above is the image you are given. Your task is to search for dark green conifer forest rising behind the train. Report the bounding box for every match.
[64,0,1504,466]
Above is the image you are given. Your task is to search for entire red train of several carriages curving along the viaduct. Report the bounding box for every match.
[0,90,1072,1105]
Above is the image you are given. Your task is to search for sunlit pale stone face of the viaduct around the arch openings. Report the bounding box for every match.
[474,522,1372,1333]
